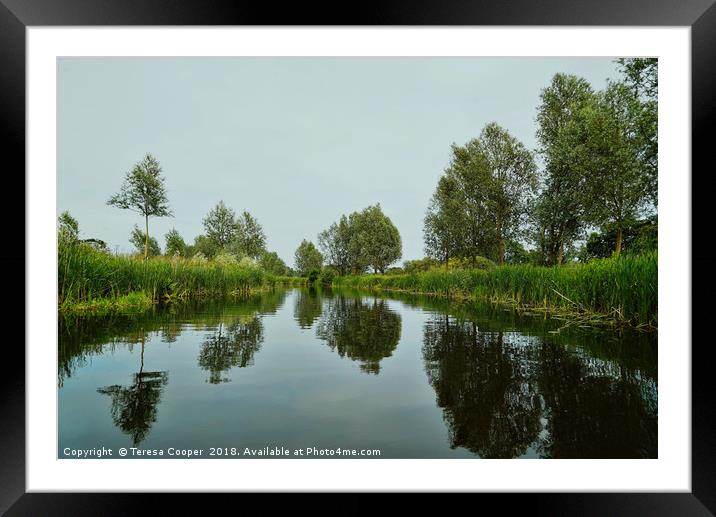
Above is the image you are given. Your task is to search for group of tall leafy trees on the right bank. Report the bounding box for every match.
[424,58,658,265]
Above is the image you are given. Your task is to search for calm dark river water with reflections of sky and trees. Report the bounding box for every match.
[58,289,657,458]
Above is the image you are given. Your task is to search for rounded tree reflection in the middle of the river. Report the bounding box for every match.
[316,296,401,374]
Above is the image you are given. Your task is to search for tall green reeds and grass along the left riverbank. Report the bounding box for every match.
[57,242,276,312]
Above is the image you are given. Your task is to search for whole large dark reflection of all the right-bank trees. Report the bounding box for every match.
[423,314,657,458]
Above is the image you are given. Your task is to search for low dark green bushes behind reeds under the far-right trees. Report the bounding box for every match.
[579,216,659,262]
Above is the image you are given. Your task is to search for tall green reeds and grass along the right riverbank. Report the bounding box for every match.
[333,252,658,328]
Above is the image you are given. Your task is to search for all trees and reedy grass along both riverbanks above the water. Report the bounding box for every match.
[58,59,658,329]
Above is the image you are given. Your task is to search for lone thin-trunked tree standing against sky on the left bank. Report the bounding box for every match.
[107,154,172,259]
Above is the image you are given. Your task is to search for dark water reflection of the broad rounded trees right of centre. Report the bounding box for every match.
[423,315,542,458]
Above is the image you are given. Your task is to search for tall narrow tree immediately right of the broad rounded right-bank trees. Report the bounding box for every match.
[532,74,594,264]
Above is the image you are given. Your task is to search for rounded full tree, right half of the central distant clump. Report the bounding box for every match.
[349,204,402,273]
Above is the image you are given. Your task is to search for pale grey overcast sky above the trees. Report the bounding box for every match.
[57,58,618,266]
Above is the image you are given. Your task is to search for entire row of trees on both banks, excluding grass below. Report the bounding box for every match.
[59,58,658,276]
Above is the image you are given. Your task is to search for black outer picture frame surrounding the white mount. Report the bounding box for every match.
[0,0,716,516]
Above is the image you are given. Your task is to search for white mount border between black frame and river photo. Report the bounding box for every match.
[26,26,691,492]
